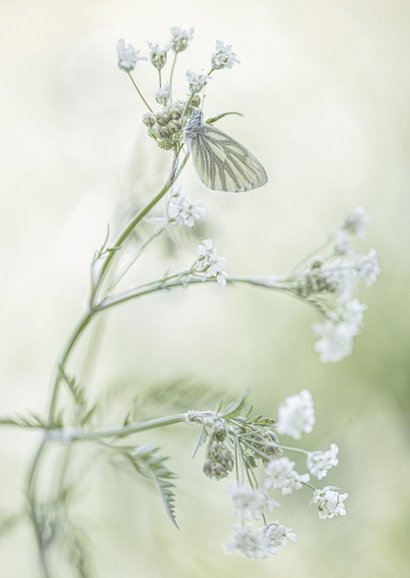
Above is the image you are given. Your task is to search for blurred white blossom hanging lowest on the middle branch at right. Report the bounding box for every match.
[312,299,366,362]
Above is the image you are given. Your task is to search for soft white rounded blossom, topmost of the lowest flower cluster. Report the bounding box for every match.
[276,389,315,439]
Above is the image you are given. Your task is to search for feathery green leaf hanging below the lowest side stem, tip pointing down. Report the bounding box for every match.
[123,444,178,528]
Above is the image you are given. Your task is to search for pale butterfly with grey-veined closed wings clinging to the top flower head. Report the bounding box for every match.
[184,110,268,193]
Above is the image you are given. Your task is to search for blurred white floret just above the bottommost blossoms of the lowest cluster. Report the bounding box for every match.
[228,482,279,520]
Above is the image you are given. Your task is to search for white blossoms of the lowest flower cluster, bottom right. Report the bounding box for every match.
[223,390,348,559]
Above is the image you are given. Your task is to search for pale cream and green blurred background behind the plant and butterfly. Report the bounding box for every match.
[0,0,410,578]
